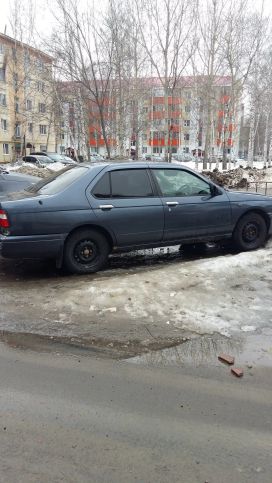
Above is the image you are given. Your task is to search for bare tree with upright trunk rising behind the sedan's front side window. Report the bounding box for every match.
[134,0,196,161]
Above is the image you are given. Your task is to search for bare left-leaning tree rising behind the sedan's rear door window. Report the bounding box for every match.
[50,0,113,157]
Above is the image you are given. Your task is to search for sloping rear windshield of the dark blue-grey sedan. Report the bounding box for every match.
[26,166,88,195]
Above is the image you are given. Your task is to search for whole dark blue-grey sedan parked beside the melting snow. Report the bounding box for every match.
[0,162,272,273]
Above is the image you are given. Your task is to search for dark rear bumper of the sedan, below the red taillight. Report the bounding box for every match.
[0,234,66,258]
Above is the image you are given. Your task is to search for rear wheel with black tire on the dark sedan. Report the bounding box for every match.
[64,229,110,274]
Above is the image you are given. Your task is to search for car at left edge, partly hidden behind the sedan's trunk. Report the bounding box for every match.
[0,167,40,198]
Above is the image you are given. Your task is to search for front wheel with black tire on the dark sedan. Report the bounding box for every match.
[233,213,267,251]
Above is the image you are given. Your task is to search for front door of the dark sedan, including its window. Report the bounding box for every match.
[152,168,231,241]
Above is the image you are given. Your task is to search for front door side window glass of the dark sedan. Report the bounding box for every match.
[152,169,211,196]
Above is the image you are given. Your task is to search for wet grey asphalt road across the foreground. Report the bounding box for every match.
[0,345,272,483]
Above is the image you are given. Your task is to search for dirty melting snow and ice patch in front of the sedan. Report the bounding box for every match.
[50,244,272,335]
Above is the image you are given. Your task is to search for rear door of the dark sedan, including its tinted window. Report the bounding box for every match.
[89,166,164,246]
